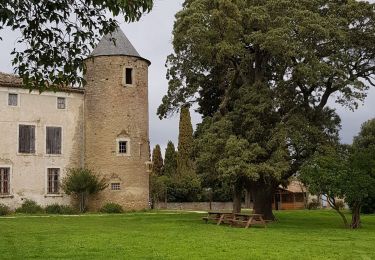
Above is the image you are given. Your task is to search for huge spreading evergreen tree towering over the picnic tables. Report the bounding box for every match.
[158,0,375,219]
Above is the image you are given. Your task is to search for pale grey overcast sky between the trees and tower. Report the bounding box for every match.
[0,0,375,154]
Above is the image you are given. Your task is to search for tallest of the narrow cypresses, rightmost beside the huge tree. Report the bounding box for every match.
[177,106,193,177]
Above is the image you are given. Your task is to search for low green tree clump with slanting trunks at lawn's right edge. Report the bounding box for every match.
[301,119,375,228]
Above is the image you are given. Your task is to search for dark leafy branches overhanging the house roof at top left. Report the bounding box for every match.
[0,0,153,91]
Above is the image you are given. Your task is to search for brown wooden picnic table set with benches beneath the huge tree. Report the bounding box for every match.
[202,211,267,228]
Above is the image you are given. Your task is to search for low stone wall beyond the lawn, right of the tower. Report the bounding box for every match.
[155,202,250,211]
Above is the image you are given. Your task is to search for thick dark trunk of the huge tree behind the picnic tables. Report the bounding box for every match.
[250,182,275,221]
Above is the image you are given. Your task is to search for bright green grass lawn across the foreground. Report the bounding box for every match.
[0,211,375,259]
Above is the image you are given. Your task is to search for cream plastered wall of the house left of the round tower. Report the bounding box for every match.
[0,87,84,208]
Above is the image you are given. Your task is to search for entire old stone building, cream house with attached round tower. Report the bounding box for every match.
[0,29,150,209]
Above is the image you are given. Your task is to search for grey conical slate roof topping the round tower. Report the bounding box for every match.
[90,27,150,63]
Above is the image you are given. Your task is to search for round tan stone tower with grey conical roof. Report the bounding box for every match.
[84,28,150,209]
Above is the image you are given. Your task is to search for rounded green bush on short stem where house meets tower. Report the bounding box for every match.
[61,168,108,212]
